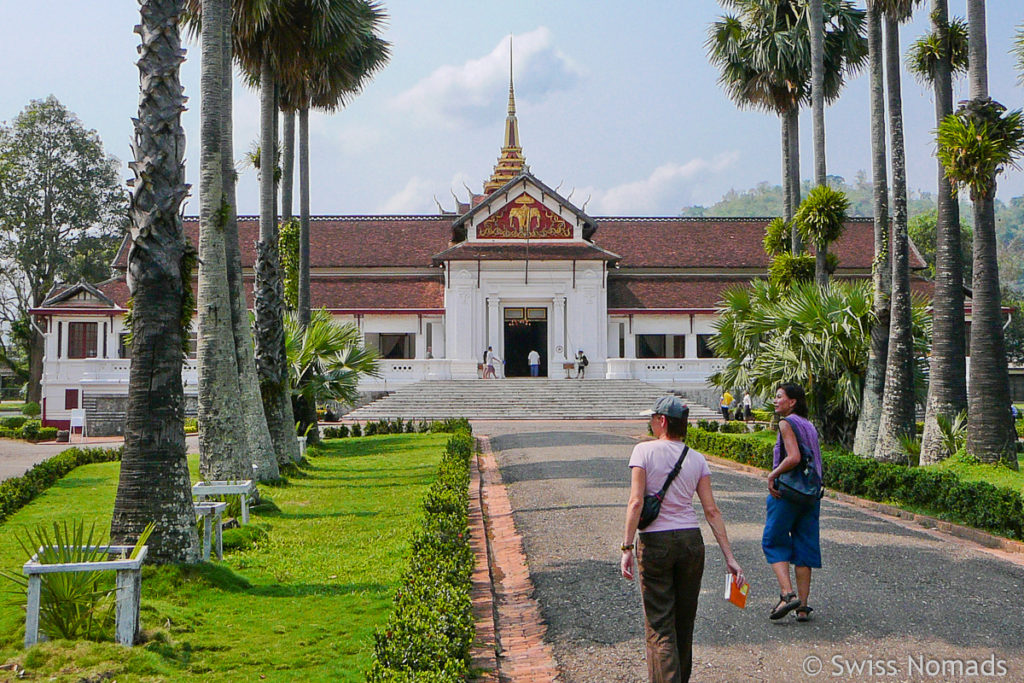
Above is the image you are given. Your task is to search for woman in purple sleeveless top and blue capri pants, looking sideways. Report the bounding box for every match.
[761,384,821,622]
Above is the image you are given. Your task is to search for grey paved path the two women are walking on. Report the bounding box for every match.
[474,422,1024,683]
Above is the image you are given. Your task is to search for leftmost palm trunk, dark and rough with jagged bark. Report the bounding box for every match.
[111,0,199,563]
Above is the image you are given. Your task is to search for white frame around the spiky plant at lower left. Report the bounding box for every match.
[22,546,148,647]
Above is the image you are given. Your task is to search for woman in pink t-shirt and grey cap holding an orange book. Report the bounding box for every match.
[621,395,743,683]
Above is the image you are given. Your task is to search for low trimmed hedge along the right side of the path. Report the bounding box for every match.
[686,427,1024,540]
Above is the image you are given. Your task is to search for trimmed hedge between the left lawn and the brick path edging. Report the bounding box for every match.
[367,422,475,683]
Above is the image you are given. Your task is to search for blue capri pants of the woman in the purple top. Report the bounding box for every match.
[761,495,821,569]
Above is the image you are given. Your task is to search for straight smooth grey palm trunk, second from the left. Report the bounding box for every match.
[198,0,252,479]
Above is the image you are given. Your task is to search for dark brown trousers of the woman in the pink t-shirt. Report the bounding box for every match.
[637,528,705,683]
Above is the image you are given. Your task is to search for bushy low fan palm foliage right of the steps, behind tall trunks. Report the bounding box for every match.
[711,280,931,444]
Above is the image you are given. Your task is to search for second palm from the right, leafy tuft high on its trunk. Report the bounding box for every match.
[908,0,968,465]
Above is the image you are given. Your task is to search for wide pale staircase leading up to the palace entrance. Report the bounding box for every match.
[344,378,721,422]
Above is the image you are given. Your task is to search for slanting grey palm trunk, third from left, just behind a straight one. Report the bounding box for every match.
[221,2,281,481]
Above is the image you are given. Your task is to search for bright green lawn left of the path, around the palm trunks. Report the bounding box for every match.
[0,434,449,681]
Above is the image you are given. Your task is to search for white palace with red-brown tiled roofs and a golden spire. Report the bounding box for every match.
[31,70,924,434]
